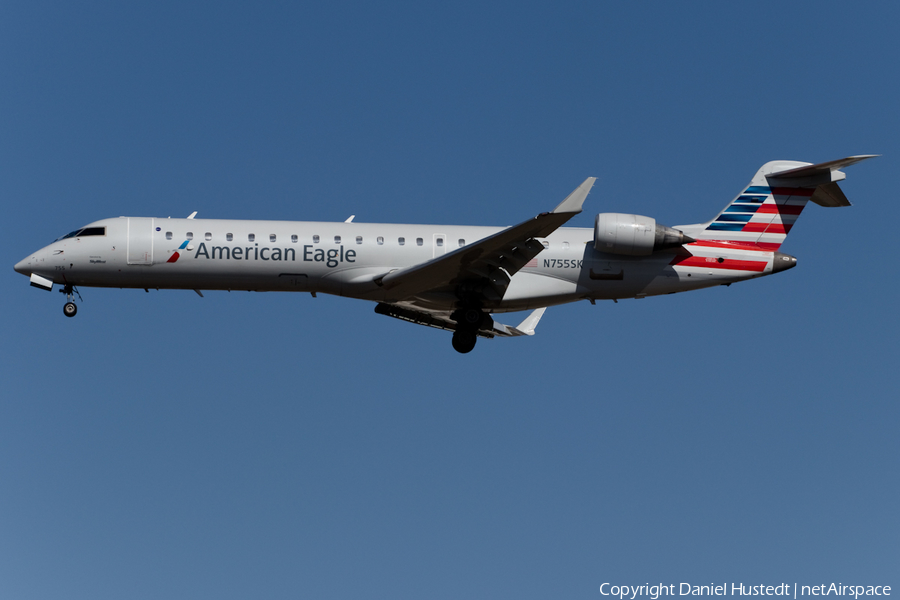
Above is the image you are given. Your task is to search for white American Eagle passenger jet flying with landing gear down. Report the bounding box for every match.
[15,155,877,353]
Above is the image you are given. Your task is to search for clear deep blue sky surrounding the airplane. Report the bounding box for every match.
[0,2,900,599]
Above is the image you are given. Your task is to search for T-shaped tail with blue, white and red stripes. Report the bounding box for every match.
[690,154,877,251]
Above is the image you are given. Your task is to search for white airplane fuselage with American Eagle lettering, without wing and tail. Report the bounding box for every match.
[16,217,777,312]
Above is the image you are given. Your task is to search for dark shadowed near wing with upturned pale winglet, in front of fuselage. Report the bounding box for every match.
[375,177,596,302]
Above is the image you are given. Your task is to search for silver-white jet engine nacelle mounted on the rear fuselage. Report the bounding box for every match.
[594,213,696,256]
